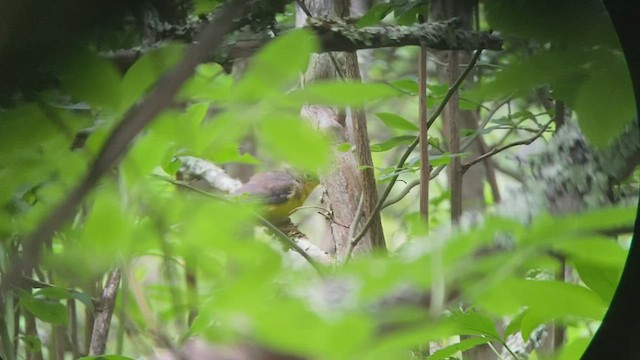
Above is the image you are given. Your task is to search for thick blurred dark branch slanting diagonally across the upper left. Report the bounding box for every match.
[0,0,244,295]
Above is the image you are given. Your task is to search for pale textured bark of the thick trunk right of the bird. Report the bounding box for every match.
[296,0,385,260]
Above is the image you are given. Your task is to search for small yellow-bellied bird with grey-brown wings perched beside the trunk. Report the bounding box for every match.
[231,169,320,225]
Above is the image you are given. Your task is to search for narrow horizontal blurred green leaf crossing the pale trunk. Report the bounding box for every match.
[291,81,401,106]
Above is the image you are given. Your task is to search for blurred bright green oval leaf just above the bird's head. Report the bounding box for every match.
[258,114,331,171]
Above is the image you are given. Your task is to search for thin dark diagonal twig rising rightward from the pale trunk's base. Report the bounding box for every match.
[344,49,482,247]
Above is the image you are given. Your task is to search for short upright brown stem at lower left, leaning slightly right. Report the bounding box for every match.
[89,269,122,355]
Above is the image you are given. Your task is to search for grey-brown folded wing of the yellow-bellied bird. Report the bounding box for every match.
[233,171,299,204]
